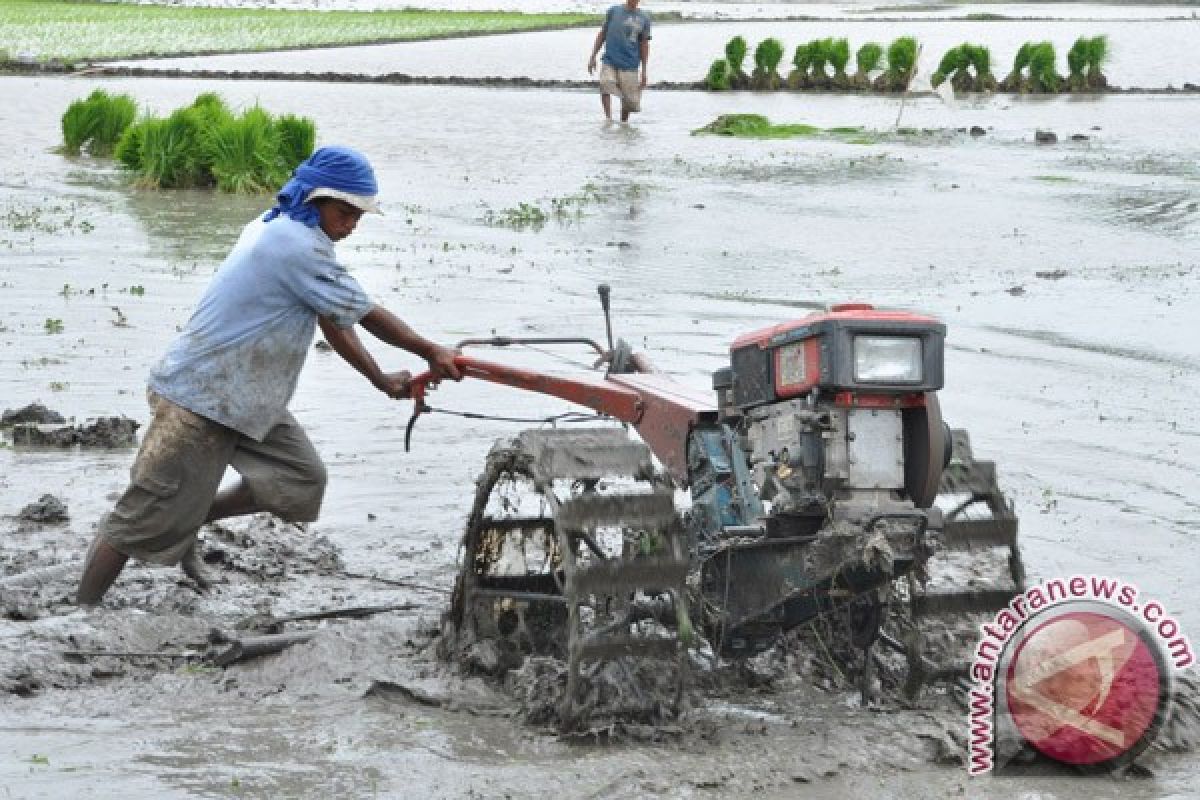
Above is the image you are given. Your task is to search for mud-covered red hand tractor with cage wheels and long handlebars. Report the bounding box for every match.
[406,285,1024,724]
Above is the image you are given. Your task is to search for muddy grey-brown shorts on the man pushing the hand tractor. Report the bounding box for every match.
[100,392,325,565]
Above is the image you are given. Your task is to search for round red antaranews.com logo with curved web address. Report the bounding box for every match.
[967,576,1194,775]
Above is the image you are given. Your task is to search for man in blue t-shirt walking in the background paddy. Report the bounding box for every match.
[588,0,650,122]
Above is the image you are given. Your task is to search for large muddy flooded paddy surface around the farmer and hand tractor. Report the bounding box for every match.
[0,78,1200,798]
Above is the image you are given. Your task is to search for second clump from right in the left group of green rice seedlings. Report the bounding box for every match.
[209,106,288,194]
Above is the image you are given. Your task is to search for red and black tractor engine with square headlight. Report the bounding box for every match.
[714,299,949,536]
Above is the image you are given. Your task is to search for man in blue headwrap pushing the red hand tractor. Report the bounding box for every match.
[78,148,461,604]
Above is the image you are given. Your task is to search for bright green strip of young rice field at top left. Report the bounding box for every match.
[0,0,600,61]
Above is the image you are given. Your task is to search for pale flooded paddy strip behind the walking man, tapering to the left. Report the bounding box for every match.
[110,20,1200,89]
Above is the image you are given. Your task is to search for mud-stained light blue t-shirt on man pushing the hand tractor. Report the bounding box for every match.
[149,216,374,441]
